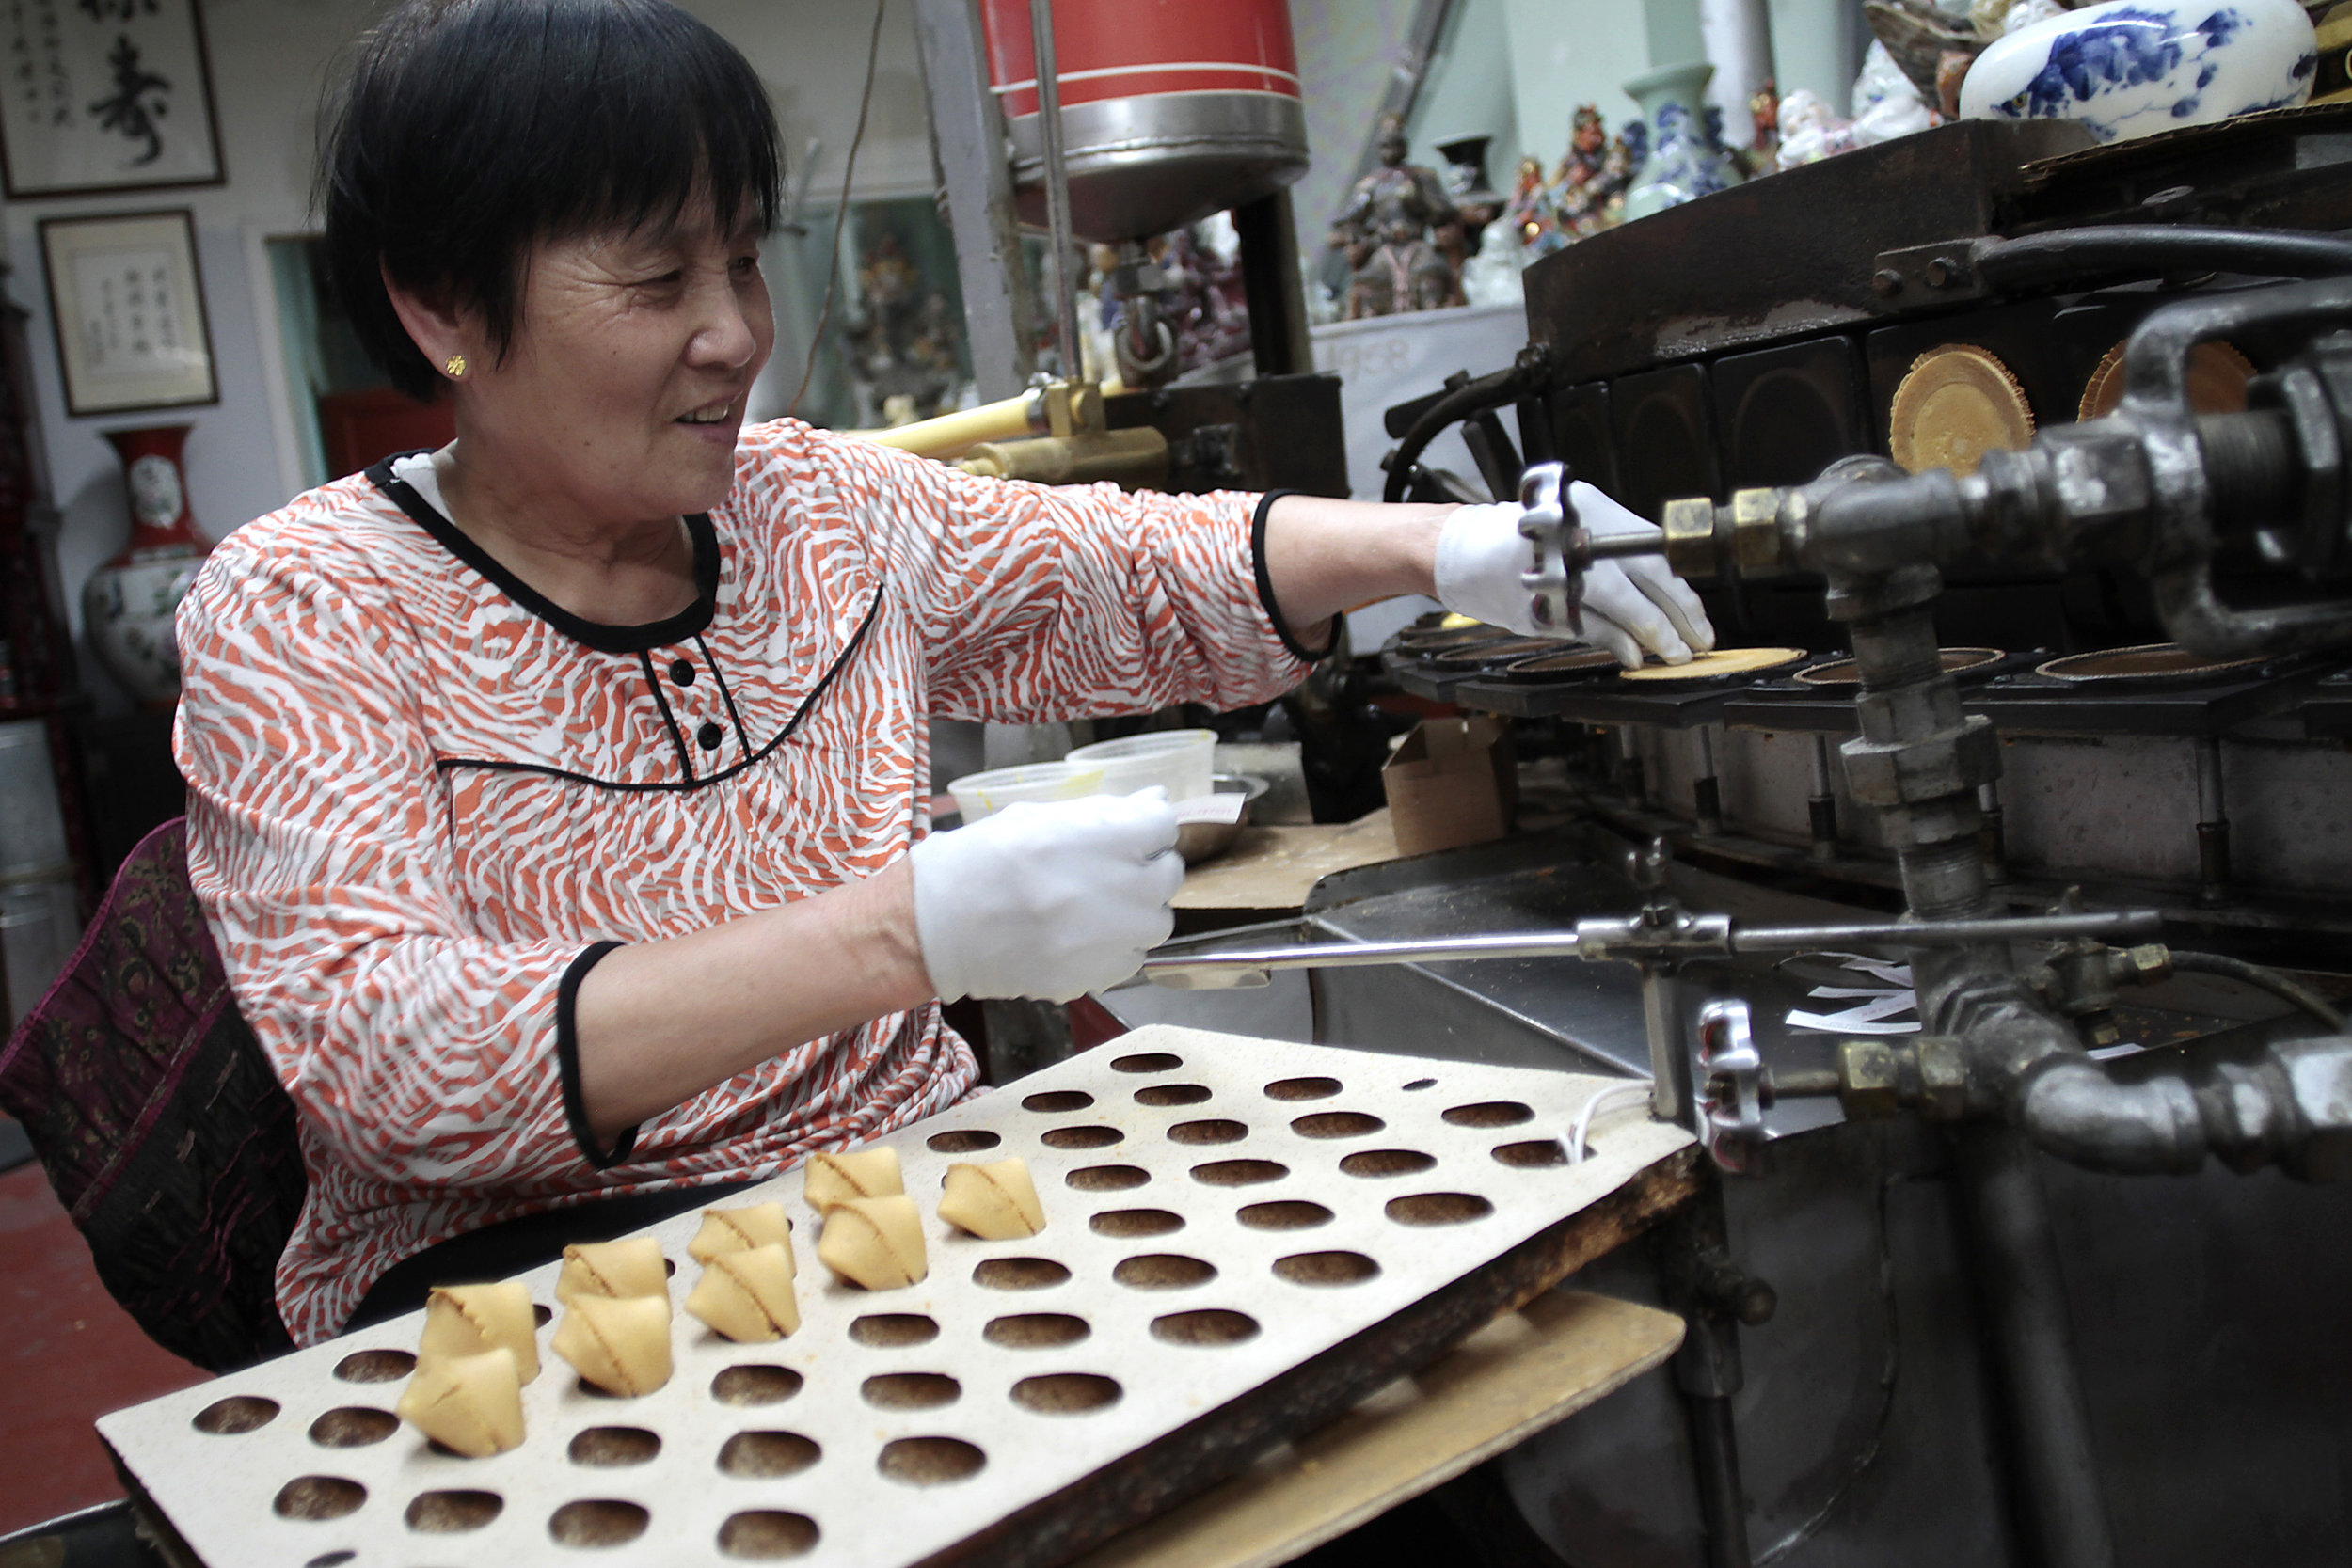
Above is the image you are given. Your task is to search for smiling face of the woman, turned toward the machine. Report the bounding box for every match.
[459,207,776,524]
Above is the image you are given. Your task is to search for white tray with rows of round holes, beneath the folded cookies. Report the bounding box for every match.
[99,1027,1692,1568]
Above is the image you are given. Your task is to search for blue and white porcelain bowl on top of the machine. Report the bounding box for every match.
[1960,0,2319,141]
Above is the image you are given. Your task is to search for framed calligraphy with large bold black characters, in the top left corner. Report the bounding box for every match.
[0,0,224,202]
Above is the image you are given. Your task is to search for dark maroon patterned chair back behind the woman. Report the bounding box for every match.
[0,818,309,1370]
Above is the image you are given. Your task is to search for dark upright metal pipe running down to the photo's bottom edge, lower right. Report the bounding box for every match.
[1955,1124,2115,1568]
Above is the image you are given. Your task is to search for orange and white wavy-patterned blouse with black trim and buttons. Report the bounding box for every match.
[177,420,1303,1345]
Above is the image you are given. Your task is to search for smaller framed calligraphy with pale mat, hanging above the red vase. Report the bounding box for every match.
[40,207,221,414]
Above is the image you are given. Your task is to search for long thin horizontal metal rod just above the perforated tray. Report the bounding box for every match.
[1143,910,2164,980]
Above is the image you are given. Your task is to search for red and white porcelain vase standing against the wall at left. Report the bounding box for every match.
[83,425,212,707]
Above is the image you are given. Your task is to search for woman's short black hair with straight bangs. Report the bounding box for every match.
[320,0,784,400]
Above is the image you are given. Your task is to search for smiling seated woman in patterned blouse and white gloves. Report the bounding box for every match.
[177,0,1708,1345]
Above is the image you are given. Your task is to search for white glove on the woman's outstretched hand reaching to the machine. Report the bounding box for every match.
[1438,480,1715,670]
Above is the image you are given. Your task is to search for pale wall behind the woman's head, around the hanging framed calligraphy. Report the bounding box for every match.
[0,0,931,698]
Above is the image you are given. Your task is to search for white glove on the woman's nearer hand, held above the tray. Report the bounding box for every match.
[908,790,1184,1002]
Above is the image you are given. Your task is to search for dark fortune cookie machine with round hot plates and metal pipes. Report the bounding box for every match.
[1129,105,2352,1568]
